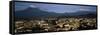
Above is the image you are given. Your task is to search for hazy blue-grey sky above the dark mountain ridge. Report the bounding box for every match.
[15,2,96,13]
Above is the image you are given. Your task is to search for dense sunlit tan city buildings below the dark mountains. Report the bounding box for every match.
[15,17,97,33]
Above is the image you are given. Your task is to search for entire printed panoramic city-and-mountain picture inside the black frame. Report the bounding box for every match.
[14,2,97,34]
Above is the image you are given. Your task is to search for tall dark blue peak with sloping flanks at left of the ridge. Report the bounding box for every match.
[15,7,61,17]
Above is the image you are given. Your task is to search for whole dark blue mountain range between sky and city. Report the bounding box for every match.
[15,7,96,17]
